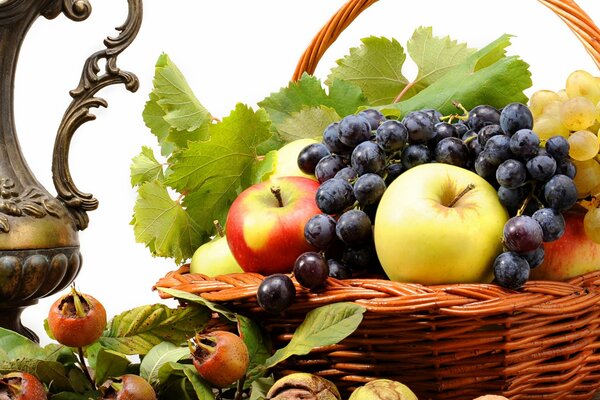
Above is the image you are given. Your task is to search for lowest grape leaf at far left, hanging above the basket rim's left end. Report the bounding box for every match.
[131,181,204,263]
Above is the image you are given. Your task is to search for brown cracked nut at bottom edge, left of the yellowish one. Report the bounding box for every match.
[267,372,341,400]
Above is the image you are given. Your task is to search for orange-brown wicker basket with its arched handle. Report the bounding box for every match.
[156,0,600,400]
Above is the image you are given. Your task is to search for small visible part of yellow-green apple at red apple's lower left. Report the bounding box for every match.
[190,236,244,278]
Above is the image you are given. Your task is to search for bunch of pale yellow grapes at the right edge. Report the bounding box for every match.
[530,70,600,243]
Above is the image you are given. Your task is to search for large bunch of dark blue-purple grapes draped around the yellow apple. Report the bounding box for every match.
[284,103,577,296]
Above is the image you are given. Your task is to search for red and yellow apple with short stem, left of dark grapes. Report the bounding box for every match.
[226,176,321,275]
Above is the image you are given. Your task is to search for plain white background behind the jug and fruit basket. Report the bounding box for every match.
[10,0,600,343]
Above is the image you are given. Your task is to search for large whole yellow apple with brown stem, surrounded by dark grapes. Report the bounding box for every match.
[374,163,508,285]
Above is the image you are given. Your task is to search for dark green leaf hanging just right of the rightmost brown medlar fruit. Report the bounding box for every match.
[237,315,271,386]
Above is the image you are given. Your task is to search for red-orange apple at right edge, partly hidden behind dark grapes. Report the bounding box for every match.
[529,210,600,281]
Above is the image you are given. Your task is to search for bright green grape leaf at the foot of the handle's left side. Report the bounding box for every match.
[258,73,366,128]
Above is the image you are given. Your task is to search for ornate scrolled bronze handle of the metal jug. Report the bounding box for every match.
[52,0,142,230]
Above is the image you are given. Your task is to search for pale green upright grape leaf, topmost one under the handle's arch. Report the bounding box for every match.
[406,27,475,92]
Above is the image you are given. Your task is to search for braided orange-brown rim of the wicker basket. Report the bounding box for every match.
[152,264,600,317]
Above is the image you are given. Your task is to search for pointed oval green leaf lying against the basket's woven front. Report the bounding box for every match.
[265,303,366,368]
